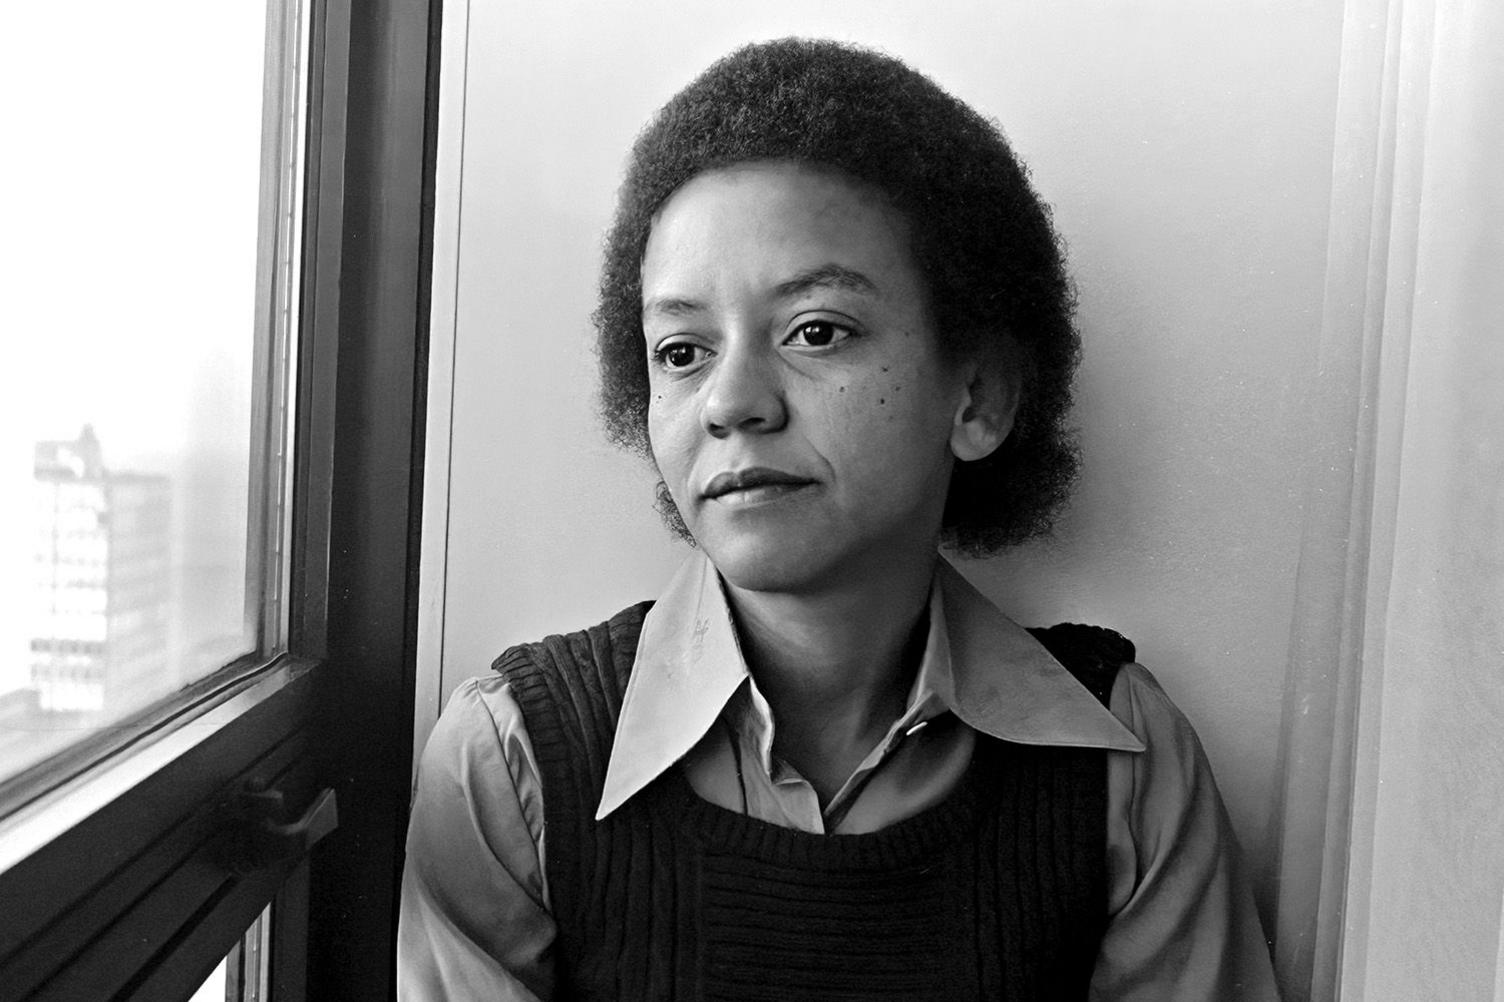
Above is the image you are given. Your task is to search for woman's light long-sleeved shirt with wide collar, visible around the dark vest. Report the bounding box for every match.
[397,554,1278,1002]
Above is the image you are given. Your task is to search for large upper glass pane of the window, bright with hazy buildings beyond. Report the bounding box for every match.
[0,0,296,779]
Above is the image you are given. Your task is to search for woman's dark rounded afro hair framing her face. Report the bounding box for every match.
[594,39,1080,557]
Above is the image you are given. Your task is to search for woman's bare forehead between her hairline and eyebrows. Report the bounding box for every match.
[642,161,919,307]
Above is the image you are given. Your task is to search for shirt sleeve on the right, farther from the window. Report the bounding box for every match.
[1090,665,1278,1002]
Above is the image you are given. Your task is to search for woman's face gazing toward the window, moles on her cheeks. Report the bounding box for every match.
[642,162,969,593]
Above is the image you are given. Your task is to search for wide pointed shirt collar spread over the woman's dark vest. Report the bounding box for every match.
[596,554,1143,818]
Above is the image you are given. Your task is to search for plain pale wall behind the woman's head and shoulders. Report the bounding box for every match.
[420,0,1342,920]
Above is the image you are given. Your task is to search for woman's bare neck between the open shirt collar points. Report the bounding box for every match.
[726,551,934,803]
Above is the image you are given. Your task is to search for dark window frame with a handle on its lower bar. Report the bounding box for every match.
[0,0,441,1002]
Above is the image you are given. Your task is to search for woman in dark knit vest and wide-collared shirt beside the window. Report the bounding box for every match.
[399,39,1274,999]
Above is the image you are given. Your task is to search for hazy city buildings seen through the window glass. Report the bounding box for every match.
[0,424,254,776]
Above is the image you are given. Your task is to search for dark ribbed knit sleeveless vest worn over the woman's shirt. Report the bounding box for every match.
[493,602,1133,1002]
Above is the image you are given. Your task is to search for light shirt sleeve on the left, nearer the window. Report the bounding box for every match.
[397,677,555,1002]
